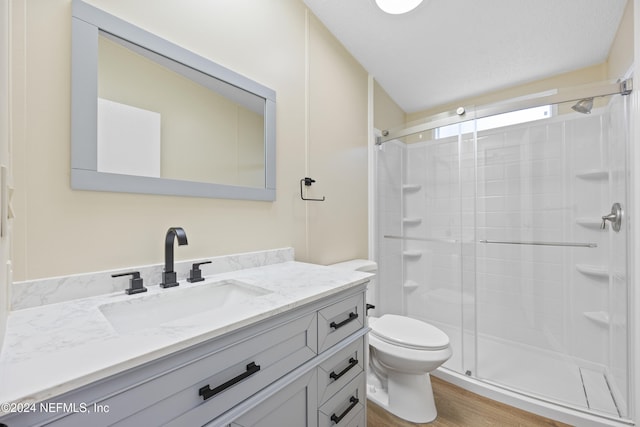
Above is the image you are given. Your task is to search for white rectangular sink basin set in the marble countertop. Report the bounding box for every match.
[99,280,271,333]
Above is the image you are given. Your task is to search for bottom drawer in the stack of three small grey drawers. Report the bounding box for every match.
[318,372,367,427]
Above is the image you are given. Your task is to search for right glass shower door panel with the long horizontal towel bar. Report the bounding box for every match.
[473,95,628,417]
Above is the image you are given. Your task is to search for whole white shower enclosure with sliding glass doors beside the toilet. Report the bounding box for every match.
[374,81,630,422]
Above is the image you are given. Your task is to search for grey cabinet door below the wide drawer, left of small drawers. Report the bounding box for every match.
[231,369,318,427]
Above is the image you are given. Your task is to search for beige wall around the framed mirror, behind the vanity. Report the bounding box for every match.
[12,0,367,280]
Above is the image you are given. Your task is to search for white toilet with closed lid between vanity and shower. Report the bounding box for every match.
[331,260,452,423]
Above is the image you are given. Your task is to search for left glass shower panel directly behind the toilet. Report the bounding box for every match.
[375,126,475,372]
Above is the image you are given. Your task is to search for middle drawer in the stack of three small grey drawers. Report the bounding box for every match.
[318,338,364,405]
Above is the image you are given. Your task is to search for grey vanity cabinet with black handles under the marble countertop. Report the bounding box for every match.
[0,284,367,427]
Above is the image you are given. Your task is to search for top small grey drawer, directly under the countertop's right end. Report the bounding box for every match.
[318,294,365,353]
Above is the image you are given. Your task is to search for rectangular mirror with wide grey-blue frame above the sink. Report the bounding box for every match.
[71,0,276,201]
